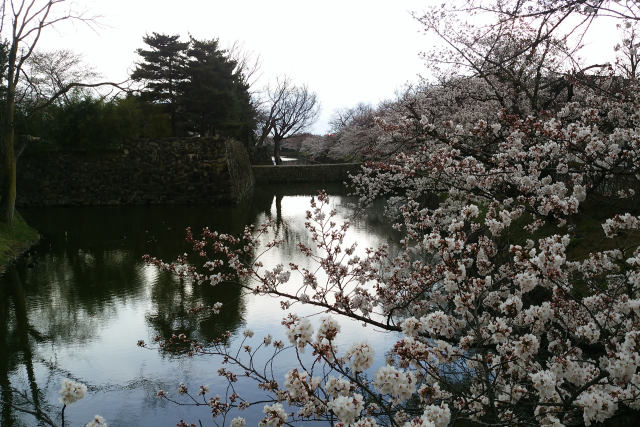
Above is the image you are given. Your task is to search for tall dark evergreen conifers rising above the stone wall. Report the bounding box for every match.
[131,33,255,144]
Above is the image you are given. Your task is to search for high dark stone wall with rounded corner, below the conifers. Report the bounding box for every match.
[17,138,254,206]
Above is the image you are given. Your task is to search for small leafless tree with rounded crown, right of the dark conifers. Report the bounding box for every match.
[256,77,320,165]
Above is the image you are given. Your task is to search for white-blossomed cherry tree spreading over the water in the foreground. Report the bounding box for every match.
[139,2,640,426]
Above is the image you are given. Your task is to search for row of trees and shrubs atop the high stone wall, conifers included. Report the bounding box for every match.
[0,32,319,158]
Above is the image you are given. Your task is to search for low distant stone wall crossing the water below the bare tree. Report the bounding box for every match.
[252,163,360,184]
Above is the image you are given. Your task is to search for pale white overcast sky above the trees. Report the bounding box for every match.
[40,0,624,133]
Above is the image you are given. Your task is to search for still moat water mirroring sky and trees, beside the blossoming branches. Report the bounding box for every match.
[0,192,395,426]
